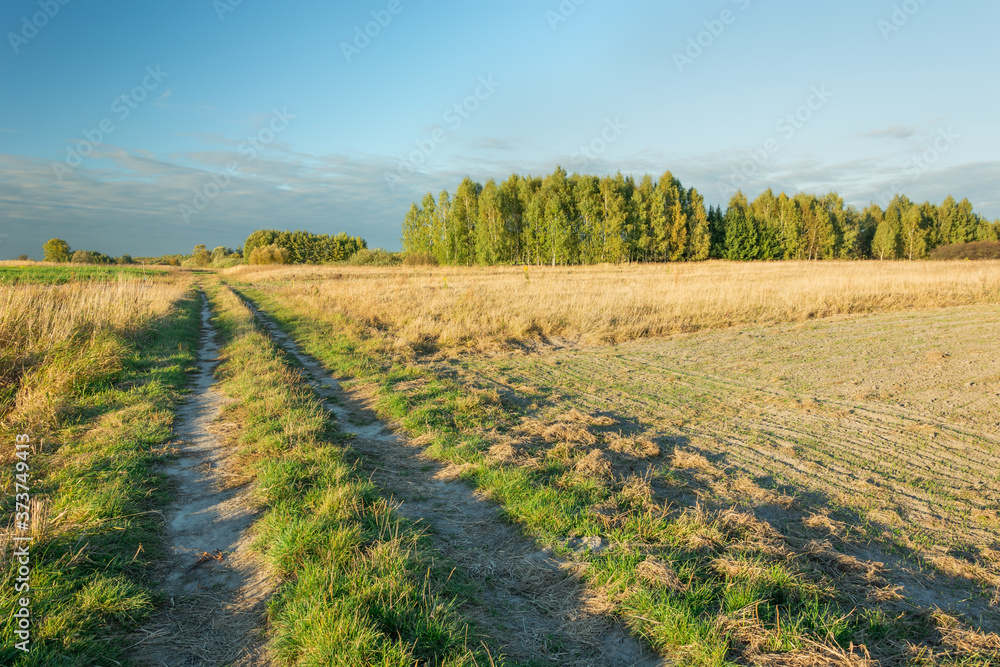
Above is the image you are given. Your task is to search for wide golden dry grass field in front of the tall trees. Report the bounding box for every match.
[224,262,1000,351]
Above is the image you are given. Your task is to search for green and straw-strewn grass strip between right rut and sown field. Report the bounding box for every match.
[236,289,996,667]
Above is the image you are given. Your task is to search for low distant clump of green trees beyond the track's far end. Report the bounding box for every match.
[243,229,368,264]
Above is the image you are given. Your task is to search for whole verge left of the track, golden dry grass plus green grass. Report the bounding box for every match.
[0,283,200,666]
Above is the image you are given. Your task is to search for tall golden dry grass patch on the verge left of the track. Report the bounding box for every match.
[0,275,190,428]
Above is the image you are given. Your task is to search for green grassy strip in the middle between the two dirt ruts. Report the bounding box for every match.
[209,286,512,667]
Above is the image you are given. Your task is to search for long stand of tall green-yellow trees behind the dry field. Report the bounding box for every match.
[402,167,1000,265]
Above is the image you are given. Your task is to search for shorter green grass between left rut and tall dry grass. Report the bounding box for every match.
[0,291,200,666]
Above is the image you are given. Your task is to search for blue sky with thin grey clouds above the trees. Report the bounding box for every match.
[0,0,1000,259]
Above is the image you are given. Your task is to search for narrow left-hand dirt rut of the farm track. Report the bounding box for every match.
[133,301,271,667]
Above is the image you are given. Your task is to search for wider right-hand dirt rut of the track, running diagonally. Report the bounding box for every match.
[233,290,669,667]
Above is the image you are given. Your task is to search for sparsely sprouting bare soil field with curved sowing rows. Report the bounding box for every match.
[458,306,1000,632]
